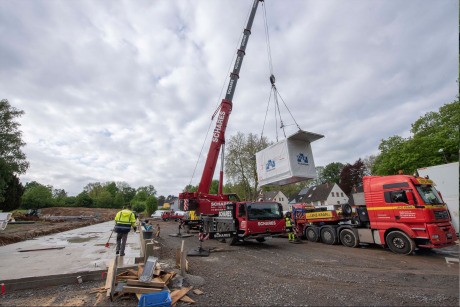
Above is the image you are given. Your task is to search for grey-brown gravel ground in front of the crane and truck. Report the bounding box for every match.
[0,221,459,306]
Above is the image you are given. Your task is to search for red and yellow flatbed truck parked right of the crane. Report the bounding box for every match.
[293,175,457,255]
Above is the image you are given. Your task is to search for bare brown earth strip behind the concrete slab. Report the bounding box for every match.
[0,207,119,245]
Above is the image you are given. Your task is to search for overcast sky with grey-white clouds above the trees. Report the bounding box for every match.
[0,0,459,195]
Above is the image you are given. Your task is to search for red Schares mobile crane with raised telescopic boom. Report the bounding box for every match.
[179,0,286,245]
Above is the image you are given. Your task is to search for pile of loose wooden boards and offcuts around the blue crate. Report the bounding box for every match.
[100,257,202,306]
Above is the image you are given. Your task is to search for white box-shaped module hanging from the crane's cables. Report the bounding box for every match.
[256,130,324,186]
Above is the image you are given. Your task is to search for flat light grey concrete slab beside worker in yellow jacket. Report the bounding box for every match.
[0,221,140,282]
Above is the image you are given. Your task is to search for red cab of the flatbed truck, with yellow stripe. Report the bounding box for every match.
[363,175,457,251]
